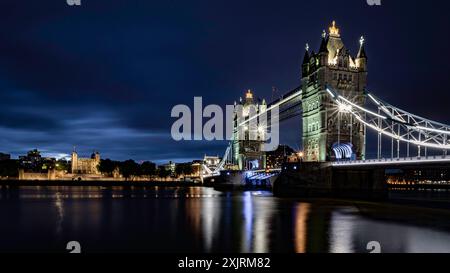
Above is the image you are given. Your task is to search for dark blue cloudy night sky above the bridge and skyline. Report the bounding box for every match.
[0,0,450,163]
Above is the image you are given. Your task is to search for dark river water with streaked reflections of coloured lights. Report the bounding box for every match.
[0,186,450,253]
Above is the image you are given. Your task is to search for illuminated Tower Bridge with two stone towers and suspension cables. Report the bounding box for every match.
[204,22,450,191]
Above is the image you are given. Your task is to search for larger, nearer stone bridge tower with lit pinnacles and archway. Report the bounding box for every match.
[302,21,367,162]
